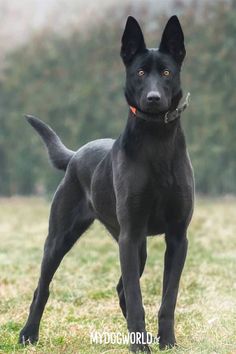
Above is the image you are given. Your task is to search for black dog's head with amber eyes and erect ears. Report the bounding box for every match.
[121,16,185,115]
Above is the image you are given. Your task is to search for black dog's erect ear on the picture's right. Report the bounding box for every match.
[159,16,186,65]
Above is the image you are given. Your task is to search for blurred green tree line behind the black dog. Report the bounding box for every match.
[0,0,236,195]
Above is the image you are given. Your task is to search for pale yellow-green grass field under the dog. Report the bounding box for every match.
[0,198,236,354]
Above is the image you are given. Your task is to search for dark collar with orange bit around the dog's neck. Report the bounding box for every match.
[130,92,190,124]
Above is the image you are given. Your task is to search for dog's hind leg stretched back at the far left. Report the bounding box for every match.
[19,176,94,344]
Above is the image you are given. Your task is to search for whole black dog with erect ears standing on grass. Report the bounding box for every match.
[20,16,194,352]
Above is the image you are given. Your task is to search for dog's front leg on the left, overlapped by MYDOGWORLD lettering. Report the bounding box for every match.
[119,228,150,353]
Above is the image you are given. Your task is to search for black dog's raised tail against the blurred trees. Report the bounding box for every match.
[26,115,75,171]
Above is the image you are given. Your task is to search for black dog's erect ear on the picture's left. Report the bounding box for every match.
[120,16,146,64]
